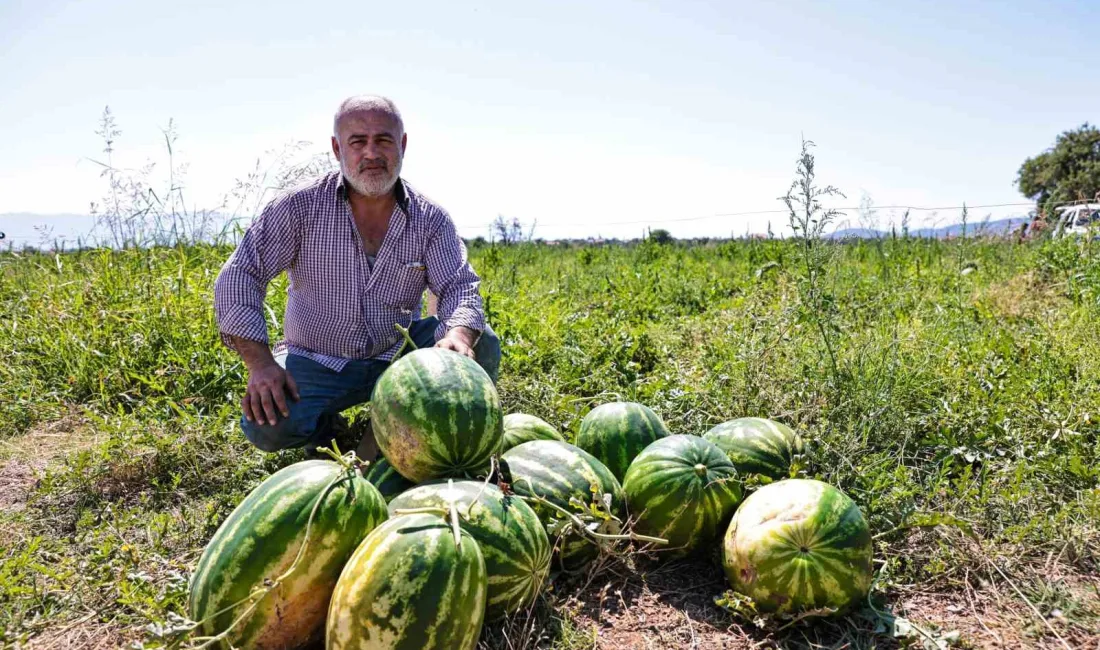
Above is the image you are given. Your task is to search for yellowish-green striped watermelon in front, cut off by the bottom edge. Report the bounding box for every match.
[326,514,488,650]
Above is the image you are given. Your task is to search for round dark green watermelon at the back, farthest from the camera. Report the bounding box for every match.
[576,401,669,481]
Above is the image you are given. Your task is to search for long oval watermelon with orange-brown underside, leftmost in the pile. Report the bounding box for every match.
[187,461,387,649]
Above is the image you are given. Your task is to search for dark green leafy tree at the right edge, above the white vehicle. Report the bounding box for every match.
[1016,122,1100,208]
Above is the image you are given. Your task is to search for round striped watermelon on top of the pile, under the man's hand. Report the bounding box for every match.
[371,348,504,483]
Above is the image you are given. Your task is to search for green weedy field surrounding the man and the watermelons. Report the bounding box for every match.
[0,230,1100,649]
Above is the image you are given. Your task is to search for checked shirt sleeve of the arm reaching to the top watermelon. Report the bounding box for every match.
[425,212,485,341]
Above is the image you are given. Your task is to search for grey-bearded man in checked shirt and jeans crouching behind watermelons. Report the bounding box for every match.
[215,97,501,460]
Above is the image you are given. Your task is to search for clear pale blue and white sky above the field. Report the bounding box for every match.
[0,0,1100,238]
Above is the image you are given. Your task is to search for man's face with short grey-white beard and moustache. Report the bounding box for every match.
[332,110,407,197]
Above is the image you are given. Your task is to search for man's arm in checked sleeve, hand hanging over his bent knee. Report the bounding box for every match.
[213,195,299,425]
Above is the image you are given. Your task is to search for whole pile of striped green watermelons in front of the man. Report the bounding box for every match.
[188,349,871,650]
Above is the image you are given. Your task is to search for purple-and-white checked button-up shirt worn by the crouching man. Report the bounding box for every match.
[213,172,485,372]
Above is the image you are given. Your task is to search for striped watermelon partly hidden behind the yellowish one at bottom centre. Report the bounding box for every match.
[389,480,550,619]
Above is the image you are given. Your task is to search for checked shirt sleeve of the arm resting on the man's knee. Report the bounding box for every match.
[213,195,300,348]
